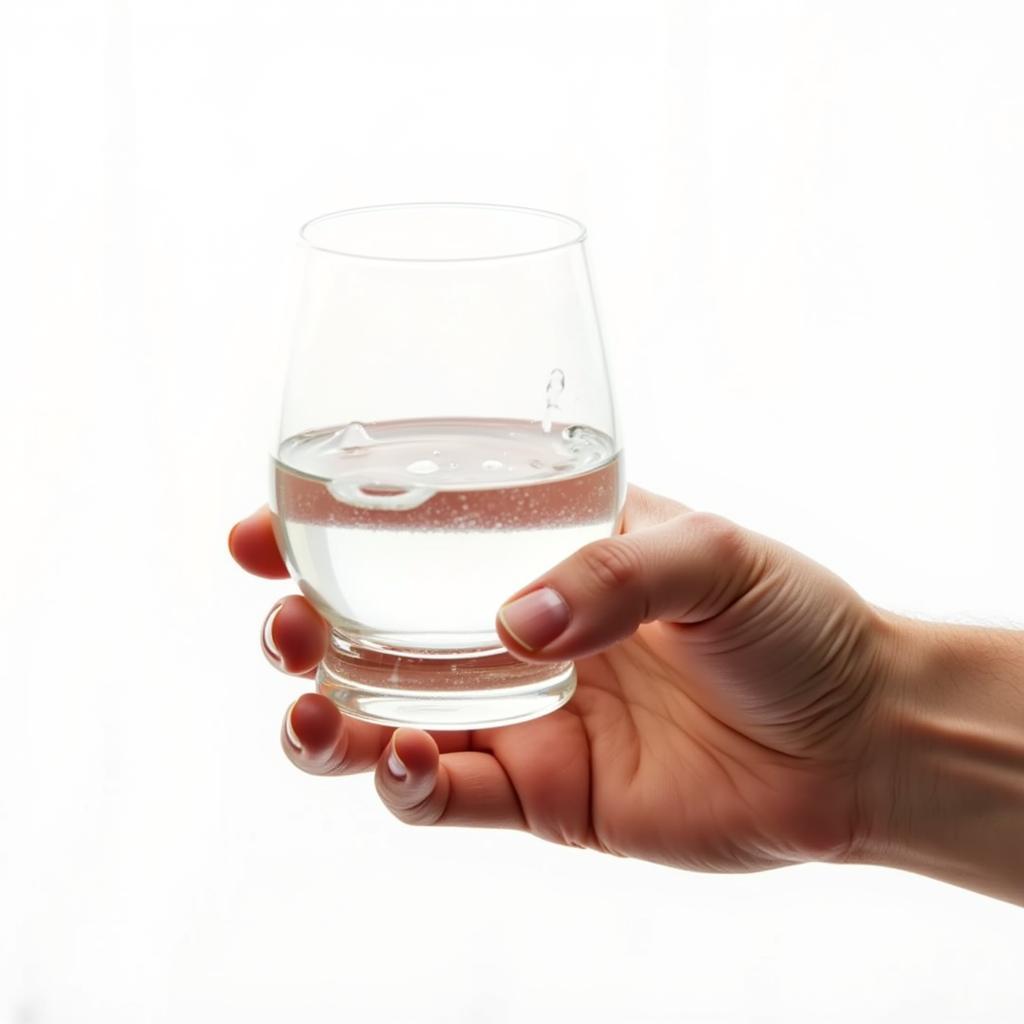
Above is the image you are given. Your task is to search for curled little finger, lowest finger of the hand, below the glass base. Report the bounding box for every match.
[376,729,526,828]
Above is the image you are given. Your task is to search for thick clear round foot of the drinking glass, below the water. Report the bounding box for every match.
[316,633,575,730]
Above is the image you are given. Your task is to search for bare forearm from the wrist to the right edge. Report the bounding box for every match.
[854,618,1024,905]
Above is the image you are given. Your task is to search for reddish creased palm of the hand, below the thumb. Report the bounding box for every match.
[481,610,872,871]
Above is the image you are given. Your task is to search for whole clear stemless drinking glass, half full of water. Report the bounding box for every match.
[271,204,626,729]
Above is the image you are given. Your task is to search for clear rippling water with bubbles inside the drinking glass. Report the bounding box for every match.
[273,419,625,652]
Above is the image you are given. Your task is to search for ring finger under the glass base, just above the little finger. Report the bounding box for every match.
[281,693,469,775]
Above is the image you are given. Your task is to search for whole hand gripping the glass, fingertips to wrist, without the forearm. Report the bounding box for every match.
[229,488,893,871]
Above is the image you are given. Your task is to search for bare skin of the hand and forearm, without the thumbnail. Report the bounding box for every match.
[228,487,1024,902]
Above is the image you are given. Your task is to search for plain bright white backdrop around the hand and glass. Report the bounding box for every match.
[0,0,1024,1024]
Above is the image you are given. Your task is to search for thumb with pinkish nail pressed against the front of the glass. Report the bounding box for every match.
[498,512,769,662]
